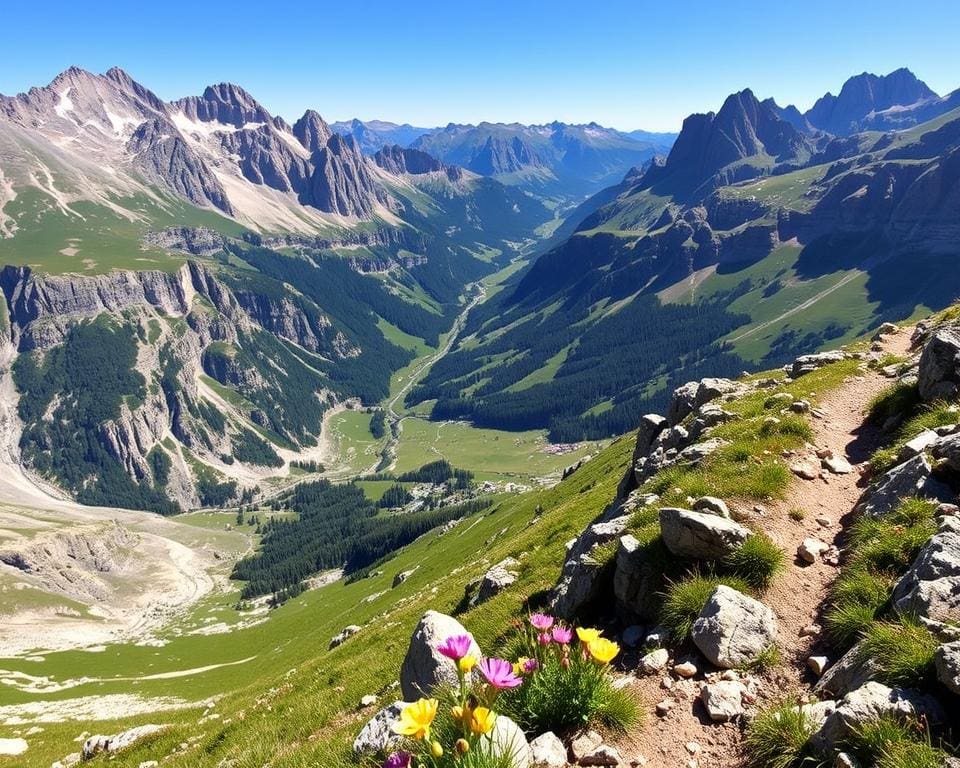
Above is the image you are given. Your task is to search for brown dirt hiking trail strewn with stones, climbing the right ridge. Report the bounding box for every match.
[615,329,910,768]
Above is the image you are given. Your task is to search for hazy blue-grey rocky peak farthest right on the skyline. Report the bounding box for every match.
[805,68,937,136]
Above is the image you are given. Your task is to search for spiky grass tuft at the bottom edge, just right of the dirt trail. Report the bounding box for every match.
[744,702,819,768]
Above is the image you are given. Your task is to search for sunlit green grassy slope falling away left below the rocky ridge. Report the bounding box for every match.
[0,428,632,768]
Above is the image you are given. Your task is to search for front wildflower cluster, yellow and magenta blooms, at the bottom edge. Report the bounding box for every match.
[384,635,533,768]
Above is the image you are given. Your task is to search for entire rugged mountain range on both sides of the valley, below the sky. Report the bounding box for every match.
[0,68,960,511]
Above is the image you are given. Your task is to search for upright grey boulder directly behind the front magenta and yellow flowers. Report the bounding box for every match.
[400,611,481,701]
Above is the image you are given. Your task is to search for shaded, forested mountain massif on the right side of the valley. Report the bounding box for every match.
[408,70,960,440]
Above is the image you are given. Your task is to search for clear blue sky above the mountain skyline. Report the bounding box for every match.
[0,0,960,130]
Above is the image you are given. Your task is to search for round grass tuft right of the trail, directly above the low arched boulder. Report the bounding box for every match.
[860,616,938,687]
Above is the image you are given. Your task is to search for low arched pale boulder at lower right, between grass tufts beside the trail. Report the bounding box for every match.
[811,682,944,748]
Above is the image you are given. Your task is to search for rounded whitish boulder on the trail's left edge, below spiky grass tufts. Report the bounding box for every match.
[691,584,777,669]
